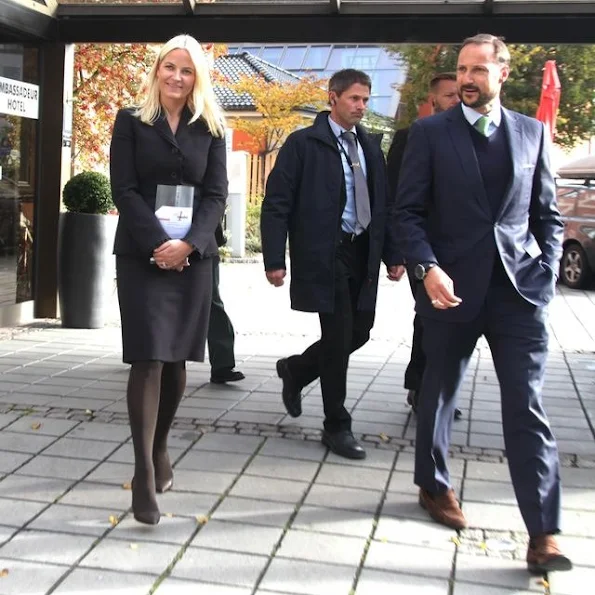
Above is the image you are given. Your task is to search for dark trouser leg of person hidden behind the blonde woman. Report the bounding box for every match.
[207,256,236,370]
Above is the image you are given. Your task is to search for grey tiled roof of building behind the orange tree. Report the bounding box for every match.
[215,52,300,111]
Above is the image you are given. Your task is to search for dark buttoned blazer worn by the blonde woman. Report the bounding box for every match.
[110,108,227,258]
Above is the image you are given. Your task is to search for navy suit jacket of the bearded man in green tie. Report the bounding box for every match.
[392,105,563,322]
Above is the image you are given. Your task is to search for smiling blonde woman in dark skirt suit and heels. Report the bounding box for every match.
[110,35,227,524]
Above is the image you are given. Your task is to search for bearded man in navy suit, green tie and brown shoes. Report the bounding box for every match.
[394,34,572,572]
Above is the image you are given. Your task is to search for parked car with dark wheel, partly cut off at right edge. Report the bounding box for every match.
[556,155,595,289]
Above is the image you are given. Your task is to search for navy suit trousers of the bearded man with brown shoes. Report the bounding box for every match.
[415,275,560,536]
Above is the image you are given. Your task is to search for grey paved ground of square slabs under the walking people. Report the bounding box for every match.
[0,264,595,595]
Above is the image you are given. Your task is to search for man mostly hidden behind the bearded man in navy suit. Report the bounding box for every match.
[386,72,463,419]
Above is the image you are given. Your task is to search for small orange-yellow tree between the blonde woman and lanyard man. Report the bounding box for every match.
[229,75,328,155]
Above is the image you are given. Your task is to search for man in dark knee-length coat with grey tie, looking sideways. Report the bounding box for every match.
[261,69,404,459]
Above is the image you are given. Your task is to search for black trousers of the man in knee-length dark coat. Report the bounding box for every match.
[288,234,374,432]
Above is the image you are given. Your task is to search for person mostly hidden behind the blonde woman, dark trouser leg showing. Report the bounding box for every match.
[207,223,246,384]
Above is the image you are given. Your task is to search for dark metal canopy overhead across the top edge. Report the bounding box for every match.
[0,0,595,44]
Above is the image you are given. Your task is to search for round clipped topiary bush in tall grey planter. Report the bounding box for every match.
[58,172,118,328]
